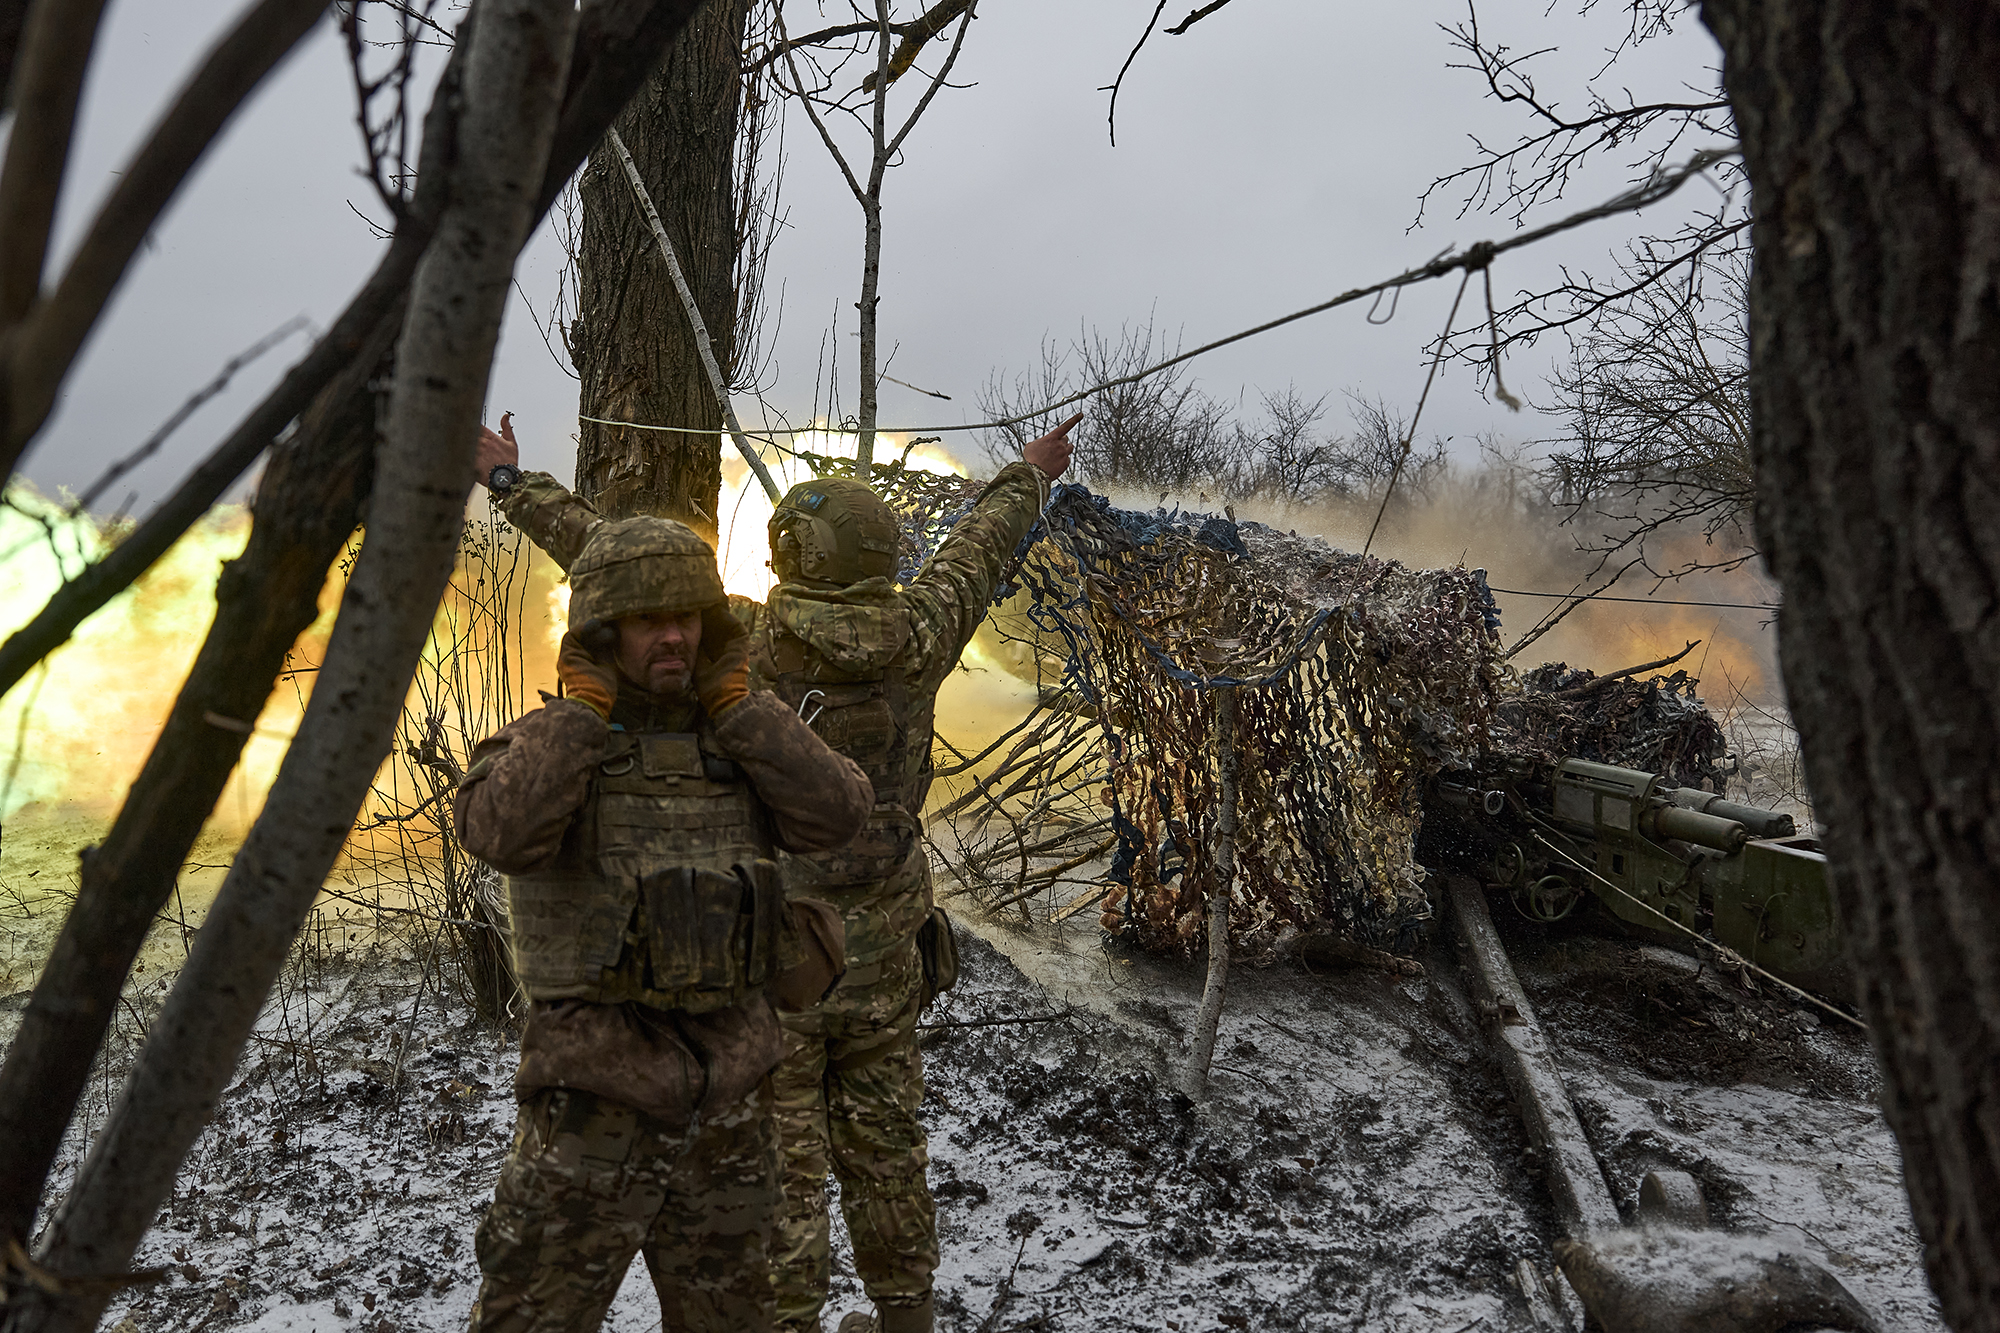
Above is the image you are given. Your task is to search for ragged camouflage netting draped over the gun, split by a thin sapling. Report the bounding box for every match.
[1020,486,1502,953]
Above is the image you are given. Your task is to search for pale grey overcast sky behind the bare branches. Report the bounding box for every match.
[24,0,1714,510]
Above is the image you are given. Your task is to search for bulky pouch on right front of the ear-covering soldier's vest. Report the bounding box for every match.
[638,861,806,1013]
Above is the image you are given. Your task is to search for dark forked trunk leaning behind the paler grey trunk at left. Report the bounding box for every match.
[0,0,712,1251]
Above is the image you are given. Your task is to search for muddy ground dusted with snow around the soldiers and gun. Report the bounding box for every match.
[0,880,1940,1333]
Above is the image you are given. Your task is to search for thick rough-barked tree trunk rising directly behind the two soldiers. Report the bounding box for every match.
[570,0,750,540]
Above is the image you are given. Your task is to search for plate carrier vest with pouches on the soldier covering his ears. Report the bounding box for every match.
[506,725,804,1013]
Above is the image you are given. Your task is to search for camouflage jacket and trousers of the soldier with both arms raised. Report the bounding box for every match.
[500,462,1050,1329]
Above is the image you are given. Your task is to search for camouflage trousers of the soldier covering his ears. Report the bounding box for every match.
[472,1081,778,1333]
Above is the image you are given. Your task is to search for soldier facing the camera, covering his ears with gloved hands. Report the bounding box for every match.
[454,518,874,1333]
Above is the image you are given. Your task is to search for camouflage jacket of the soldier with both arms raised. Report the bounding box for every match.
[498,462,1050,969]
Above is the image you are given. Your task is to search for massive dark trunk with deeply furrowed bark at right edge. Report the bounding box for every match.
[1702,0,2000,1331]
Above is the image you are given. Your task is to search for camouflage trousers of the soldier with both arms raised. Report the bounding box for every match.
[772,941,938,1333]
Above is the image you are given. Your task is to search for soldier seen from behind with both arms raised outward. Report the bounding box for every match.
[480,414,1082,1333]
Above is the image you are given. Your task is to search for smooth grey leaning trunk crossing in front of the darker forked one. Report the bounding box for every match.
[8,0,576,1333]
